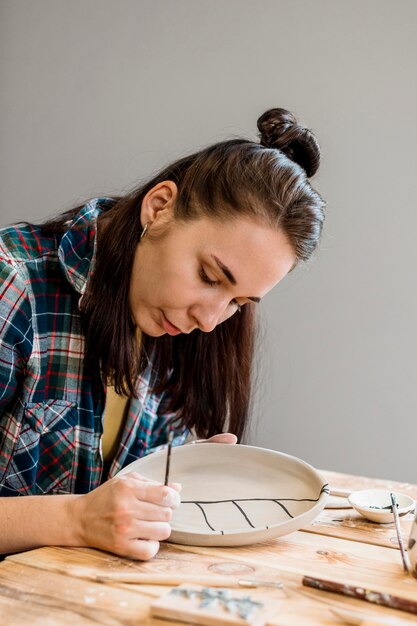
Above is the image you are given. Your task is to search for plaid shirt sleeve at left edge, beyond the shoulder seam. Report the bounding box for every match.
[0,259,33,416]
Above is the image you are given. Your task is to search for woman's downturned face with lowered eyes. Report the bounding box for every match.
[129,201,296,337]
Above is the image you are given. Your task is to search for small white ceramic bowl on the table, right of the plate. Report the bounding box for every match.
[348,489,415,524]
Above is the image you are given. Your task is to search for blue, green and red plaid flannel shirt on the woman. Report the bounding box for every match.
[0,198,188,496]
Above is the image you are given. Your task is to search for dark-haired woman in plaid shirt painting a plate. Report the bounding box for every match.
[0,109,324,559]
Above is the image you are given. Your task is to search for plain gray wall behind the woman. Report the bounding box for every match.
[0,0,417,482]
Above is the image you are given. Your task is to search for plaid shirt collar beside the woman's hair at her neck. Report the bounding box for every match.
[58,198,114,295]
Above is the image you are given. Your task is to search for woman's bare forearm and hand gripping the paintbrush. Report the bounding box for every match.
[0,472,181,560]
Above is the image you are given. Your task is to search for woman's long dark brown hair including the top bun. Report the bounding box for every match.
[40,109,324,438]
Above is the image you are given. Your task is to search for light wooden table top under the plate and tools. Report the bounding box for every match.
[0,471,417,626]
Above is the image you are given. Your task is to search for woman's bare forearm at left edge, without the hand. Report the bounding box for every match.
[0,495,82,554]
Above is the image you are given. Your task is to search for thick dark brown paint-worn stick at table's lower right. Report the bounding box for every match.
[302,576,417,615]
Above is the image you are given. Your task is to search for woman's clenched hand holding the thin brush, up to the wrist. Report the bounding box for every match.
[74,472,181,560]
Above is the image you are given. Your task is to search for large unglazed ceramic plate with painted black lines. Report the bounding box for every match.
[119,443,329,546]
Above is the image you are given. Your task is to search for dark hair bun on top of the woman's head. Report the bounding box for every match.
[257,109,320,178]
